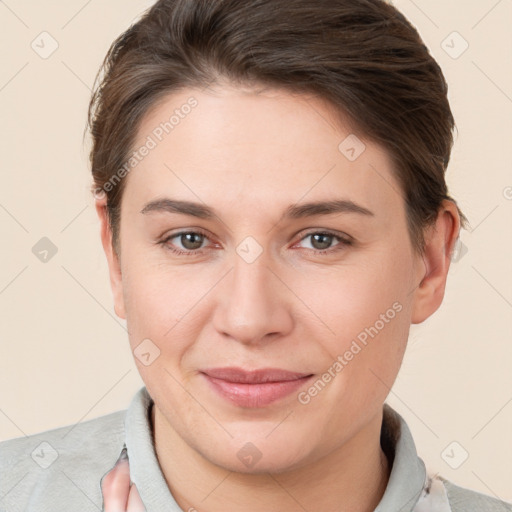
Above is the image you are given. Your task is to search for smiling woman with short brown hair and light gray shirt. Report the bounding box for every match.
[1,0,512,512]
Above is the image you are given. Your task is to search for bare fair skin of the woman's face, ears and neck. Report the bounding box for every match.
[96,84,460,512]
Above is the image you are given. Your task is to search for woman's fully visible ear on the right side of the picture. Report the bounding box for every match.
[411,199,460,324]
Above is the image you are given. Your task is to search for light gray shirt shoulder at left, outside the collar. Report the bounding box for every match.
[0,410,126,512]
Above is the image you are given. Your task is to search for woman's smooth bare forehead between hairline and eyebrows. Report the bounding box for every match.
[125,87,403,217]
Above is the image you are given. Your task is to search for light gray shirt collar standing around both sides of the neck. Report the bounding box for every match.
[125,386,428,512]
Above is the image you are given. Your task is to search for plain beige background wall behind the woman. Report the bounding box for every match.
[0,0,512,500]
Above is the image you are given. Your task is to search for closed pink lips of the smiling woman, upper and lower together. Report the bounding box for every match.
[201,367,313,408]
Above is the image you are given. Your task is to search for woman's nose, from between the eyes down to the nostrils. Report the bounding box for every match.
[214,247,293,345]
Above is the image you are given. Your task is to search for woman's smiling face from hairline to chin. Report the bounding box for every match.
[100,86,444,472]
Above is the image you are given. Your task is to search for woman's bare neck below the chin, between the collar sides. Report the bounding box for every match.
[151,405,391,512]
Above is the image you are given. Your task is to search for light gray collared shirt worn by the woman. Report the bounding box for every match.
[0,387,512,512]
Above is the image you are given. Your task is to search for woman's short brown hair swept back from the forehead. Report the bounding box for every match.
[88,0,468,253]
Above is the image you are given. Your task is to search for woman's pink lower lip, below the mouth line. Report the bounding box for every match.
[203,374,313,408]
